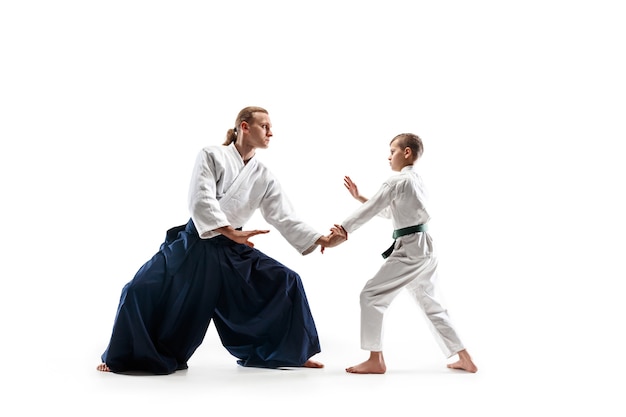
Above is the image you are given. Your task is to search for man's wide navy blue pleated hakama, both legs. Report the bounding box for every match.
[102,220,321,374]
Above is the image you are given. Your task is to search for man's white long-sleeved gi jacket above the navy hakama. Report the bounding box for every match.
[189,144,322,255]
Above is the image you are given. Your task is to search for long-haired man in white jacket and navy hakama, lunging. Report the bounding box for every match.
[97,107,347,374]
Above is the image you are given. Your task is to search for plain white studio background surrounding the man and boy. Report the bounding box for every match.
[0,0,626,416]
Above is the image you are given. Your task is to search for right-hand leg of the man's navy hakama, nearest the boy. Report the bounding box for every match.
[213,247,320,367]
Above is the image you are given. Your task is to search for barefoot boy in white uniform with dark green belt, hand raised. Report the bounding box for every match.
[341,133,478,374]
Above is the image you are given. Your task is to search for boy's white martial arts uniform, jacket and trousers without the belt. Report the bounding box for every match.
[341,166,464,357]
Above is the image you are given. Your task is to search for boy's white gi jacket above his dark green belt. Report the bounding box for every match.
[341,165,430,233]
